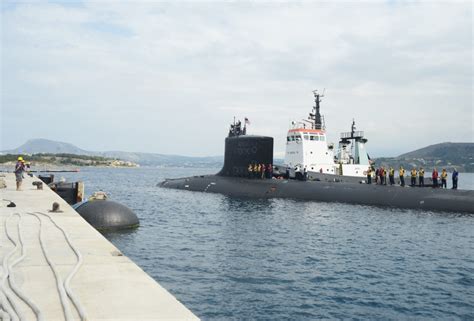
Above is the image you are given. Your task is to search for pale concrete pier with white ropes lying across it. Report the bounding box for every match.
[0,173,198,321]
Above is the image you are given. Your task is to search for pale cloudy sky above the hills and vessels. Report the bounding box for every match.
[0,0,474,157]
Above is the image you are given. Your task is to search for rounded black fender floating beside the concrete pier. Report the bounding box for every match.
[74,200,140,230]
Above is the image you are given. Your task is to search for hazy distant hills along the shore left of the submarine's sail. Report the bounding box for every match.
[2,139,224,167]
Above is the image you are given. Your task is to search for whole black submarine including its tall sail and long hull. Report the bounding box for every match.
[158,94,474,214]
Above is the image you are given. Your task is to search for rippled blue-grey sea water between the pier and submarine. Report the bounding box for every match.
[56,168,474,320]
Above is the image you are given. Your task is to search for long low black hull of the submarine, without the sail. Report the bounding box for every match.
[158,175,474,214]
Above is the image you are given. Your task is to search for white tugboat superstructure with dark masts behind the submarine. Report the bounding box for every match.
[285,90,370,178]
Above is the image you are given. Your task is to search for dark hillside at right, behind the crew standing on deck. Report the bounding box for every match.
[375,143,474,172]
